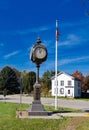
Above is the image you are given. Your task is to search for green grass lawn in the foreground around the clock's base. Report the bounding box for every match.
[0,102,89,130]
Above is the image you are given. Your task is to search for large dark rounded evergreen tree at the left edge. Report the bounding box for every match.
[0,66,19,92]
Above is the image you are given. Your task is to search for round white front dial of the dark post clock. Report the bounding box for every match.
[35,47,46,59]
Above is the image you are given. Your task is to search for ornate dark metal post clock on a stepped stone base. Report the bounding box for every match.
[28,37,48,116]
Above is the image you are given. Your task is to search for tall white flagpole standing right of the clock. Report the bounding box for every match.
[55,20,58,110]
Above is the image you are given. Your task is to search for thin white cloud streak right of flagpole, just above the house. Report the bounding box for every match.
[59,56,89,65]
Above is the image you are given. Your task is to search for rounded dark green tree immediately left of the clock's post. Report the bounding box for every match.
[22,71,36,93]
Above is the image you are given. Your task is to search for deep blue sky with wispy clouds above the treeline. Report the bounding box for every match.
[0,0,89,75]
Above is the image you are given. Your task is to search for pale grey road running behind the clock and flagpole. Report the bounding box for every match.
[0,95,89,112]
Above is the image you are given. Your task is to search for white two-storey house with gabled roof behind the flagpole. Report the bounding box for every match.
[51,72,81,98]
